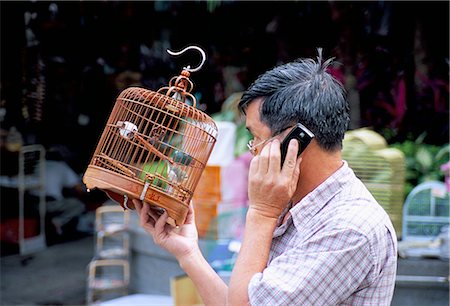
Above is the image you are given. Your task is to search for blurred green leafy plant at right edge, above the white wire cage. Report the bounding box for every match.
[391,133,450,194]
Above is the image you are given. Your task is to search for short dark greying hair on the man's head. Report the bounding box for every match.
[238,48,350,151]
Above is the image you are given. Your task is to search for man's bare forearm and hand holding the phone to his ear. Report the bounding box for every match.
[228,139,301,305]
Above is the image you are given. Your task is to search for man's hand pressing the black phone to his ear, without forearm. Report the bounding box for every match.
[248,139,301,219]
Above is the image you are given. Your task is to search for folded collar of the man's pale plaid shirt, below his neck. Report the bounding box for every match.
[290,161,354,229]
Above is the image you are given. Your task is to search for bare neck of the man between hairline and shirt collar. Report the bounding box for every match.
[292,143,343,205]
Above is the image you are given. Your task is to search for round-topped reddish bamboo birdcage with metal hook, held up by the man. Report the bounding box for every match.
[83,46,218,226]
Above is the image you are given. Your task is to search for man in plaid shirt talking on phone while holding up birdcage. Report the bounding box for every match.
[134,49,397,305]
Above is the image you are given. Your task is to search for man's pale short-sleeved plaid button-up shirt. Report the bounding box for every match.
[248,162,397,306]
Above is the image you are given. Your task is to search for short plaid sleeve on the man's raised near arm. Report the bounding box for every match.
[248,229,374,305]
